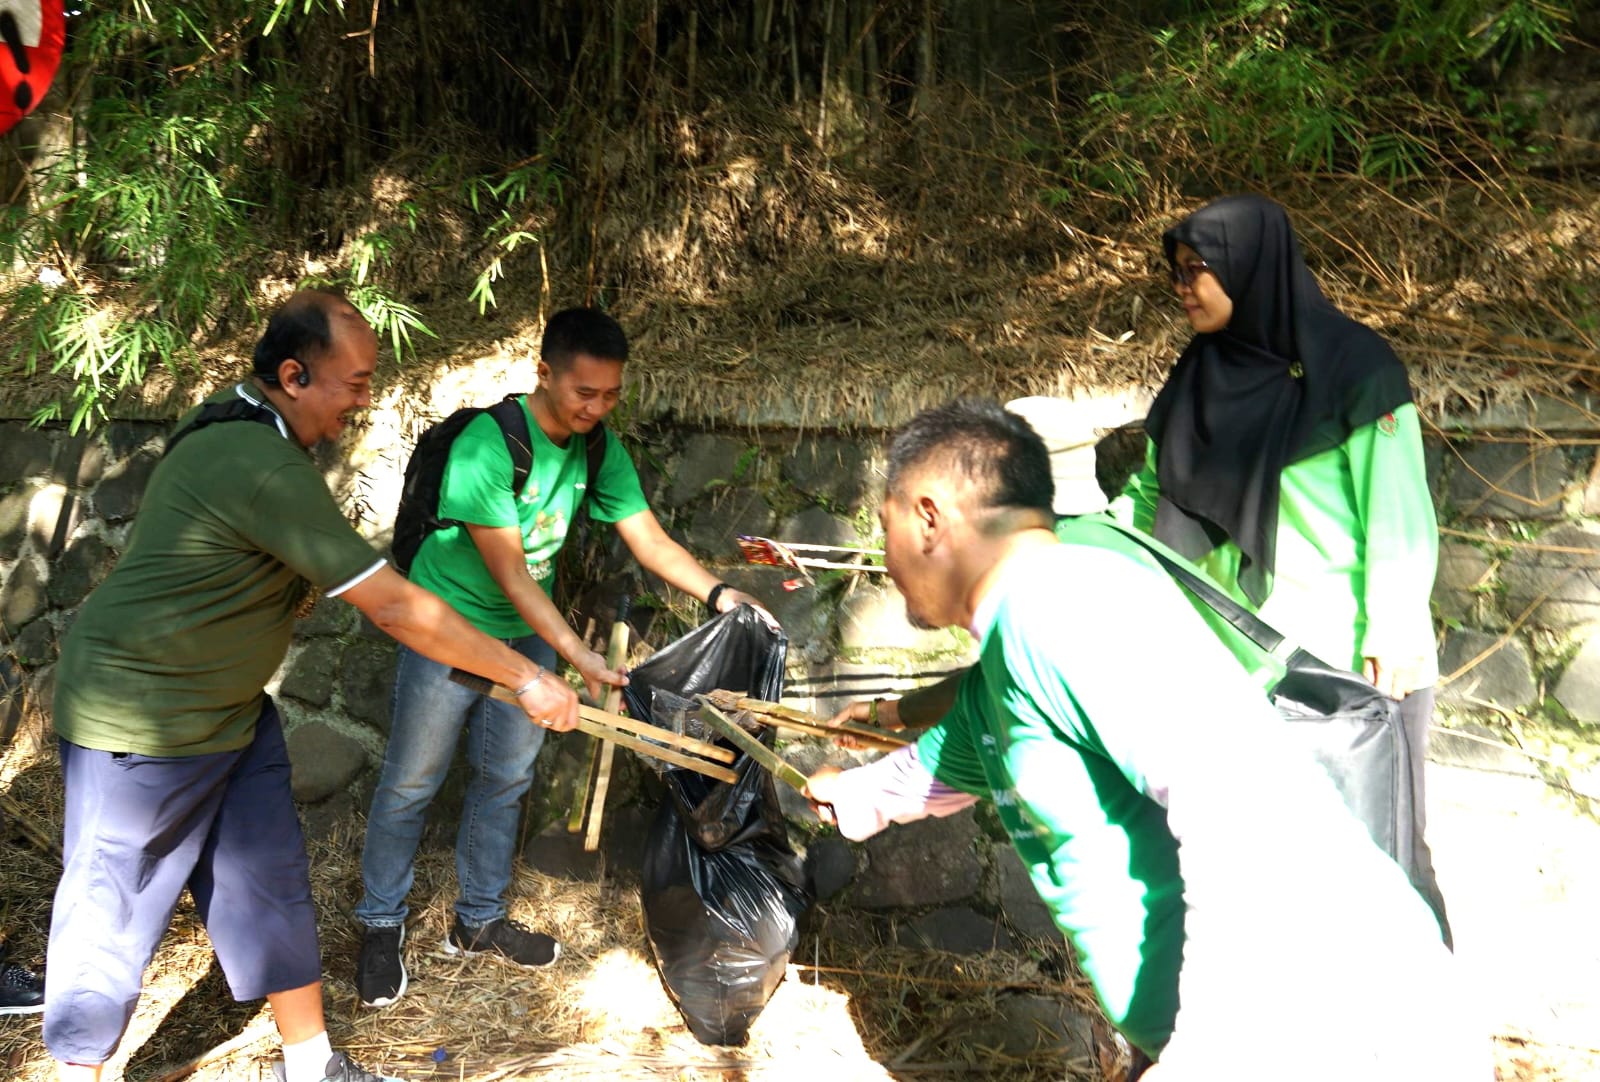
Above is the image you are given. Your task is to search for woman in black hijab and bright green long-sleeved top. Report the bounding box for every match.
[1126,195,1448,936]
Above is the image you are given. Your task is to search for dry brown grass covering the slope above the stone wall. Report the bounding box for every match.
[0,89,1600,429]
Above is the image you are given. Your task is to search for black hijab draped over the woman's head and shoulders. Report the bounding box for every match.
[1146,195,1411,605]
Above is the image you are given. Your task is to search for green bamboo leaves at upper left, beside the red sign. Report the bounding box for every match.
[0,0,444,431]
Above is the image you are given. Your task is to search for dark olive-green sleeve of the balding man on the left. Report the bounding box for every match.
[240,459,381,591]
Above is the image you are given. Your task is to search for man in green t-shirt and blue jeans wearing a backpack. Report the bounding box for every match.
[355,307,758,1007]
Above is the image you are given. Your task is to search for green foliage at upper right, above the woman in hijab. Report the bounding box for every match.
[1045,0,1573,202]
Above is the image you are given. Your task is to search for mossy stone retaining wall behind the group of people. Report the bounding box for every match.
[9,402,1600,949]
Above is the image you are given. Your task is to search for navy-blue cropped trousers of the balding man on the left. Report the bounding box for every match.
[45,698,322,1063]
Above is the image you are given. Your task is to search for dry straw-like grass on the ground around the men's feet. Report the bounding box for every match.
[0,726,1120,1082]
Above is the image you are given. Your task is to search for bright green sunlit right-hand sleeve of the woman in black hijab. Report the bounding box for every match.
[1344,403,1438,658]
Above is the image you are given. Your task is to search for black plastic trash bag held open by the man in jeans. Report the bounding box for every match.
[626,608,811,1045]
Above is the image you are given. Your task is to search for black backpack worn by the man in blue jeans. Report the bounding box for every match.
[389,394,605,575]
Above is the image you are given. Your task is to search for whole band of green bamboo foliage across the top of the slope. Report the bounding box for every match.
[0,0,1576,426]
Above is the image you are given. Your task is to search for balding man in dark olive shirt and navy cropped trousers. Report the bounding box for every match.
[45,291,578,1082]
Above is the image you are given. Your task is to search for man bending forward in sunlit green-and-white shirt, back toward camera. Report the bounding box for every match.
[808,400,1490,1082]
